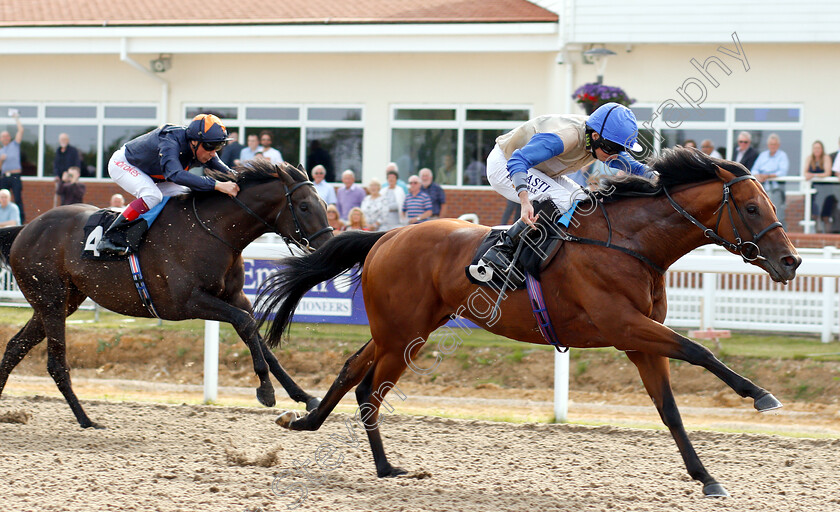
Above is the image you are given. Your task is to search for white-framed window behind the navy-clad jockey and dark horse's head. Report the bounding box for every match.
[184,104,364,181]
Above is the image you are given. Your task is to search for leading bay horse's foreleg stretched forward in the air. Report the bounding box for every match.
[614,313,782,412]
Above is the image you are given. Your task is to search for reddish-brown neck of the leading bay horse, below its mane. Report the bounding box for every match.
[601,184,720,269]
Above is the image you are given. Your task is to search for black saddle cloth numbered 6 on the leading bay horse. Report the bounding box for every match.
[464,200,563,290]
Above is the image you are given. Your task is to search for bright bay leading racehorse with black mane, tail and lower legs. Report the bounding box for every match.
[257,148,801,496]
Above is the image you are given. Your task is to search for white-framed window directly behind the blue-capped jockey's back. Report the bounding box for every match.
[391,105,531,186]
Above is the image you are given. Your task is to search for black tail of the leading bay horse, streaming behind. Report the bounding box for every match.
[254,231,385,347]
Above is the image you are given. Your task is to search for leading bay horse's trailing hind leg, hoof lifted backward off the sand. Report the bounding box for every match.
[277,340,376,430]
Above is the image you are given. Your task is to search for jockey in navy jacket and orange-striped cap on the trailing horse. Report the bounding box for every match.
[96,114,239,255]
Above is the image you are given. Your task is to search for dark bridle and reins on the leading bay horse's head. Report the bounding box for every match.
[662,174,783,263]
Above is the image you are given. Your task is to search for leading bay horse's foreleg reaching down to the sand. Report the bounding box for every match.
[627,352,728,497]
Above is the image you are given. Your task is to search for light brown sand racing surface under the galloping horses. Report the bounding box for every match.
[0,395,840,512]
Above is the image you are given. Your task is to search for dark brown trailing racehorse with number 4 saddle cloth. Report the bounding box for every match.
[0,161,332,428]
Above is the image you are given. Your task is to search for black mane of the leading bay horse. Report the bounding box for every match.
[596,146,750,201]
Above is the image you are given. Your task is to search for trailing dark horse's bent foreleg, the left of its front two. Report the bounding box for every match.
[187,289,275,407]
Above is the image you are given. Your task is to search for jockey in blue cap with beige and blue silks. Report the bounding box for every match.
[483,103,655,268]
